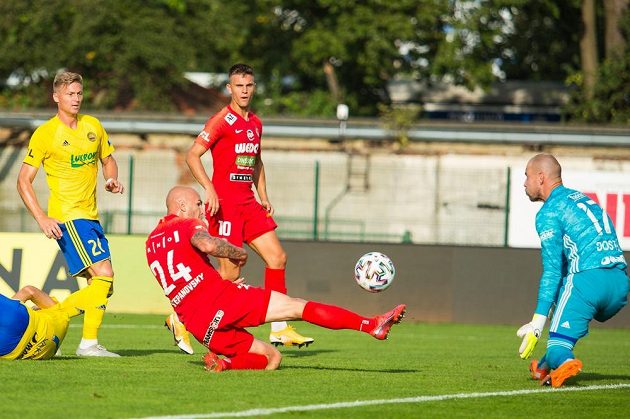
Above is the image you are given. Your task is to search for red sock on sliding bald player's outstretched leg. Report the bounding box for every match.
[302,301,376,333]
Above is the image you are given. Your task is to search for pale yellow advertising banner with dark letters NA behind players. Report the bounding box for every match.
[0,232,171,314]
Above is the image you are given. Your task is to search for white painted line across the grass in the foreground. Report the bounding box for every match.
[136,383,630,419]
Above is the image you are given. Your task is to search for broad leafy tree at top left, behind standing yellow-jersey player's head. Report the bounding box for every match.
[0,0,246,110]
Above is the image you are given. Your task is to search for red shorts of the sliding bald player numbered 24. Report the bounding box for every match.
[177,284,271,356]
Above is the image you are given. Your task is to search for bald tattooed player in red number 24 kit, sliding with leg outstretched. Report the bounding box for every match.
[146,186,405,372]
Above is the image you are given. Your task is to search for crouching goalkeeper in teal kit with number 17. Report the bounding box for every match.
[517,154,629,387]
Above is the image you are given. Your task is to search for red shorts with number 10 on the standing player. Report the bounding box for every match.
[206,199,278,247]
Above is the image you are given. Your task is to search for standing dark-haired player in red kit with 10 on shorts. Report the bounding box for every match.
[178,64,314,347]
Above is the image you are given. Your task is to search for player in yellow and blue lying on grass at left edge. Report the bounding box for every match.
[0,285,115,360]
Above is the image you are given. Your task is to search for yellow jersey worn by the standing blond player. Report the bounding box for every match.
[24,115,114,222]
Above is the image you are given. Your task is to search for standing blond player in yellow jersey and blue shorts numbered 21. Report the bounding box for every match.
[17,72,123,357]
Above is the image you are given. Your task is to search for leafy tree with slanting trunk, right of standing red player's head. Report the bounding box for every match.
[246,0,448,116]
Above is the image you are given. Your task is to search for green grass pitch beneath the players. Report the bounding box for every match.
[0,313,630,419]
